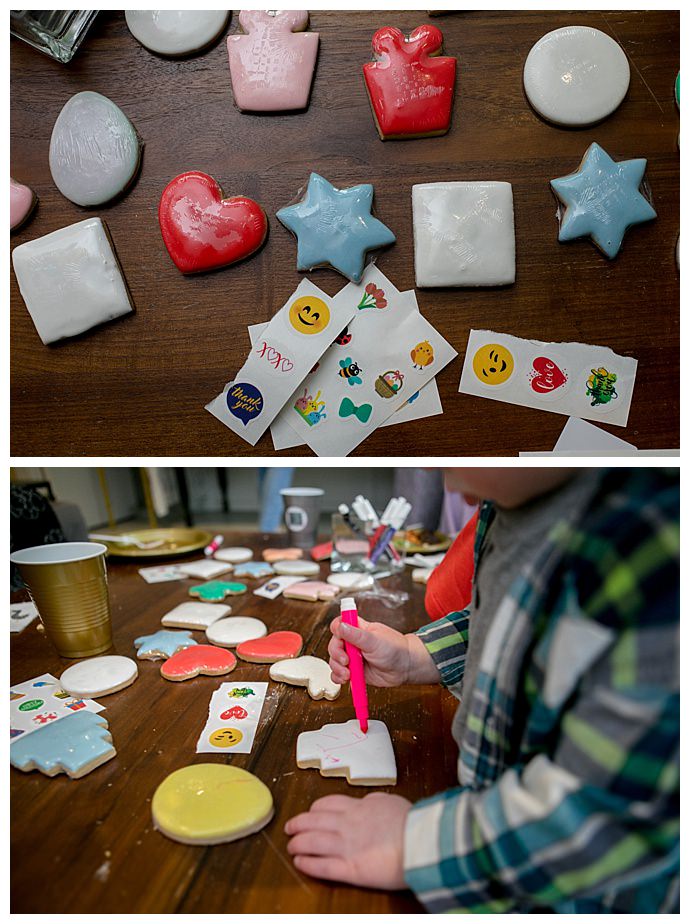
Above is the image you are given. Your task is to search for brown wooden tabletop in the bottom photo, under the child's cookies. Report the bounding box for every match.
[10,533,457,913]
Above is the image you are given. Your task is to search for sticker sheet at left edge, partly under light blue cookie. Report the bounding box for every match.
[10,674,105,740]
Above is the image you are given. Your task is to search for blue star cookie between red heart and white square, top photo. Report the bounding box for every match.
[276,173,395,282]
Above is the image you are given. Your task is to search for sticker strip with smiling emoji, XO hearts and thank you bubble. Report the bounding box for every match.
[206,279,357,446]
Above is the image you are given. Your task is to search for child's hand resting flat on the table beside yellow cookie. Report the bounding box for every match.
[285,792,412,889]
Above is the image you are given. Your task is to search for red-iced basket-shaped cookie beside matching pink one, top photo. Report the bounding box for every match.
[363,26,457,138]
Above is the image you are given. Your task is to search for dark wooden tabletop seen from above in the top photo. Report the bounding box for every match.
[11,11,679,456]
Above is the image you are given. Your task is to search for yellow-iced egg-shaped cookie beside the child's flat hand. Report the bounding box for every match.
[151,764,273,844]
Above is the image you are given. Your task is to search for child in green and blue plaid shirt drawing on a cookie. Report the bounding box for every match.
[285,468,679,913]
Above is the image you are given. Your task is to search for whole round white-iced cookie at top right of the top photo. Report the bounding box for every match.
[522,26,630,127]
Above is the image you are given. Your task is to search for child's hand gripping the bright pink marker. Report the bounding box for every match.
[328,616,439,687]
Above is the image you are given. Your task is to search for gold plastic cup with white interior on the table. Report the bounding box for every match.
[10,542,113,658]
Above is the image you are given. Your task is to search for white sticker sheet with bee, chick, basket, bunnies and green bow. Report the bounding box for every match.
[281,265,457,456]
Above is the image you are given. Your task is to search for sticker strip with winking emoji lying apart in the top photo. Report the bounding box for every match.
[458,330,637,427]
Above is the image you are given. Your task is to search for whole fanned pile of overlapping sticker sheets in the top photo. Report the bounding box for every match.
[207,265,457,456]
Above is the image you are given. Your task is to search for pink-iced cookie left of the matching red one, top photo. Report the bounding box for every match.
[228,10,319,112]
